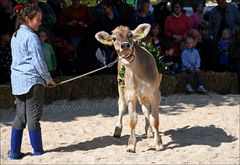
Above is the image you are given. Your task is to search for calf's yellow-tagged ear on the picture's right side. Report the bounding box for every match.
[132,23,151,40]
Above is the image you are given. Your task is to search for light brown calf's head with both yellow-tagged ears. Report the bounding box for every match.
[95,24,151,58]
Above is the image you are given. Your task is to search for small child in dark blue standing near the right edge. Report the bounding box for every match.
[218,29,232,71]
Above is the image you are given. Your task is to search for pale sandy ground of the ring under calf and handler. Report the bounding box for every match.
[0,94,240,164]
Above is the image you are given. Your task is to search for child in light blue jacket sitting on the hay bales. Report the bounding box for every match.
[182,36,207,94]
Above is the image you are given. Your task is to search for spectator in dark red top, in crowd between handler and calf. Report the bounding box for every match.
[59,0,92,48]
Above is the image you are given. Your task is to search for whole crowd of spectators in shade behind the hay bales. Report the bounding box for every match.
[0,0,240,93]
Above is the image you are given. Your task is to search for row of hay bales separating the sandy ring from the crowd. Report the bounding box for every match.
[0,72,237,108]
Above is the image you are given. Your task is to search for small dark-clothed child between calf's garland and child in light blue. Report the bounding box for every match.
[162,42,179,75]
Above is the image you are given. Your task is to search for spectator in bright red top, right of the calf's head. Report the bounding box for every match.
[164,0,192,62]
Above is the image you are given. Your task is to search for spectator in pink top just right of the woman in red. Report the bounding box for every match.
[190,3,203,28]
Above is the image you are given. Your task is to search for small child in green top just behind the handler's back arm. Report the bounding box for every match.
[39,30,57,77]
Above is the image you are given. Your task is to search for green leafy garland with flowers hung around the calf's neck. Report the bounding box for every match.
[118,43,167,85]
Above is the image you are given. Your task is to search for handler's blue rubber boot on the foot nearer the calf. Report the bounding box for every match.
[29,129,44,156]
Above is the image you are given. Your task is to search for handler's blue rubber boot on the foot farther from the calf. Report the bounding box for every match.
[9,128,25,160]
